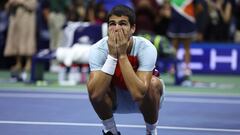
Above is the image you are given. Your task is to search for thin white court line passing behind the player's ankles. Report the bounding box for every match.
[0,121,240,133]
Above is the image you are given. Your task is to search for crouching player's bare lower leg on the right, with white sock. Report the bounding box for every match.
[140,76,164,135]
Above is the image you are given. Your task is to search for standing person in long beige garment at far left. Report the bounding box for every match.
[4,0,37,81]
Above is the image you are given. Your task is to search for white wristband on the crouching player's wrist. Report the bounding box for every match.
[101,55,117,75]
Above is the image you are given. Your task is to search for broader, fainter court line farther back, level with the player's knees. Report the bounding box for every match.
[0,93,240,104]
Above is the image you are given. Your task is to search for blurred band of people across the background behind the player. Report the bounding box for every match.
[0,0,240,82]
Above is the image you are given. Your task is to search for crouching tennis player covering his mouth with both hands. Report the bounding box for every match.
[87,5,164,135]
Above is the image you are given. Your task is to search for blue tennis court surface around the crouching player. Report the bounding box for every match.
[0,88,240,135]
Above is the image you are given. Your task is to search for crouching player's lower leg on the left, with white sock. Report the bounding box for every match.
[89,88,118,135]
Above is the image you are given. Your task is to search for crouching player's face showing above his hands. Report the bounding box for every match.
[108,15,135,37]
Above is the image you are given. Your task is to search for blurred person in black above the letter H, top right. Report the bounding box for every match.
[204,0,234,42]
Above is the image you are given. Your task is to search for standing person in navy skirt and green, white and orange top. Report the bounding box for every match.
[167,0,202,76]
